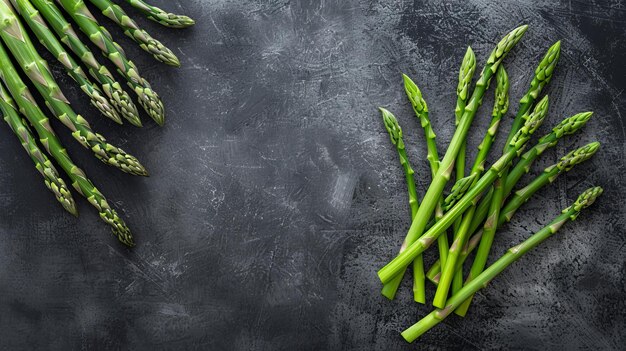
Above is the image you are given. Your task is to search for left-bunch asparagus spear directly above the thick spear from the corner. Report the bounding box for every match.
[12,0,122,124]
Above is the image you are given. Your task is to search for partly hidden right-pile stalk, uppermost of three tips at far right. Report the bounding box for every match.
[426,112,593,284]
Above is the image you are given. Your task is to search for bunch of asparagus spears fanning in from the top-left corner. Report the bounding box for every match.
[0,0,194,246]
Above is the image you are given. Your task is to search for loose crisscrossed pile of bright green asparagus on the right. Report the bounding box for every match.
[378,25,602,342]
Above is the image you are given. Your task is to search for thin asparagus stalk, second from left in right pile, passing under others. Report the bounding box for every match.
[398,74,436,303]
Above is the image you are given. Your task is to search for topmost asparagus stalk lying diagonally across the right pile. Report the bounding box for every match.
[378,91,545,284]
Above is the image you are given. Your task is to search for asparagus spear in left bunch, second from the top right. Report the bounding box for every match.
[84,0,180,67]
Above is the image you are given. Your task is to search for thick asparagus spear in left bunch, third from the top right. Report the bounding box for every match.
[59,0,165,126]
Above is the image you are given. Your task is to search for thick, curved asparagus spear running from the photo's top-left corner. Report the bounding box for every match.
[0,0,147,176]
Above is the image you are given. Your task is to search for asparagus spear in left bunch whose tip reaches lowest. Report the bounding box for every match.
[0,44,134,246]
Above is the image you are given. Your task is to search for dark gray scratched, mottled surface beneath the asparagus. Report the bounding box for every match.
[0,0,626,350]
